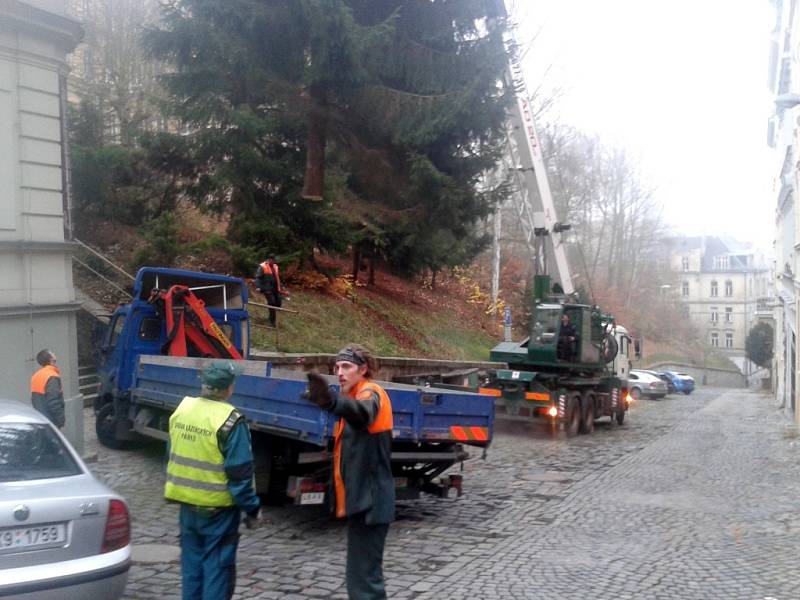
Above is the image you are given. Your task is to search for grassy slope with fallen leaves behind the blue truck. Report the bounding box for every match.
[250,289,500,360]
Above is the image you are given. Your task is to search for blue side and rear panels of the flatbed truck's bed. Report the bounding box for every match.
[131,355,494,447]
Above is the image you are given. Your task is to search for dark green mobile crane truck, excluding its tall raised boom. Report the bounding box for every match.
[482,276,633,436]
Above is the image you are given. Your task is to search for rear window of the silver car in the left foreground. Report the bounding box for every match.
[0,423,82,482]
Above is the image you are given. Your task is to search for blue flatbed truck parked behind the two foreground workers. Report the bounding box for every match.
[95,267,494,504]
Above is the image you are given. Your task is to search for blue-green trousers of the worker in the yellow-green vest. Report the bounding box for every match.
[180,504,240,600]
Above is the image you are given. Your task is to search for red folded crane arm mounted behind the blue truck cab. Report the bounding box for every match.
[150,285,242,360]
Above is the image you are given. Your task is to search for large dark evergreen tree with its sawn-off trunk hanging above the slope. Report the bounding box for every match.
[148,0,506,272]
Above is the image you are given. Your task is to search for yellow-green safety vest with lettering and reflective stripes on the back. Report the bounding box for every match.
[164,396,236,507]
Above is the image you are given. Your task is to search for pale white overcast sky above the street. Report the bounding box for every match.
[509,0,775,249]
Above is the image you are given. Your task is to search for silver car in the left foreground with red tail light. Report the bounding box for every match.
[0,400,131,600]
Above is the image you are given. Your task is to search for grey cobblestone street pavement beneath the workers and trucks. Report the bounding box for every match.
[86,389,800,600]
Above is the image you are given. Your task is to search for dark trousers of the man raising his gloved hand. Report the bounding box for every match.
[347,513,389,600]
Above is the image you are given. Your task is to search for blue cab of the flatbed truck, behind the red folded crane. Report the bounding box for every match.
[94,267,250,447]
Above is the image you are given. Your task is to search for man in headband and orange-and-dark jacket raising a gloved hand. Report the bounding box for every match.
[308,344,395,600]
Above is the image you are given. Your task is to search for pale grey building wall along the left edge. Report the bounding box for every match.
[0,0,83,451]
